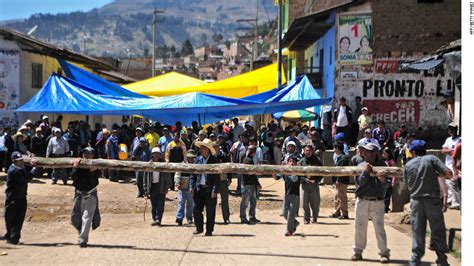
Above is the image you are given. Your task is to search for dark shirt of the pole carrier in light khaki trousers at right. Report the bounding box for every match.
[355,161,387,199]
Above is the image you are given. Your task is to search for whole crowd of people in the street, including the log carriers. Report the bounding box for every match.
[0,98,461,264]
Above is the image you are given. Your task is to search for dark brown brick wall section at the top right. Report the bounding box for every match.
[369,0,461,57]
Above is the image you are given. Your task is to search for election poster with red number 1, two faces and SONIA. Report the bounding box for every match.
[338,14,373,65]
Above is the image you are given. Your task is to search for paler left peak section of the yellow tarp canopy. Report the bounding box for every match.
[122,72,206,96]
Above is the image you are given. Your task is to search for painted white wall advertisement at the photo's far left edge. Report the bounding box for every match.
[0,46,20,128]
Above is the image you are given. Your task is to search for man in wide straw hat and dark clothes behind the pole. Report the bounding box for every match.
[189,139,220,236]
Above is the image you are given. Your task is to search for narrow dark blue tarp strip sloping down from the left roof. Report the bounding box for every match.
[57,58,149,98]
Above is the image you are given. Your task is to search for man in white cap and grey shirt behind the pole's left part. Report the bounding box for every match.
[46,128,70,185]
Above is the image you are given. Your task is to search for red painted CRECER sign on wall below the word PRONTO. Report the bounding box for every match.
[363,100,420,124]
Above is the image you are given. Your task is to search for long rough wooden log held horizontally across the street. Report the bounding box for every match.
[24,156,403,177]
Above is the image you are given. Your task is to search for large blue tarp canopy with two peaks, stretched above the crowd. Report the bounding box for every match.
[16,74,331,125]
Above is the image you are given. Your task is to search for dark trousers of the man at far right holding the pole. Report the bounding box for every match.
[410,197,448,265]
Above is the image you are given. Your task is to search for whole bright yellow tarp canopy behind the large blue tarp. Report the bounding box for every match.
[123,64,286,98]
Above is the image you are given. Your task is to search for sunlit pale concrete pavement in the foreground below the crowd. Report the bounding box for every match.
[0,209,460,265]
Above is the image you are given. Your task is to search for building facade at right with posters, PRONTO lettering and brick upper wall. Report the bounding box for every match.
[284,0,461,144]
